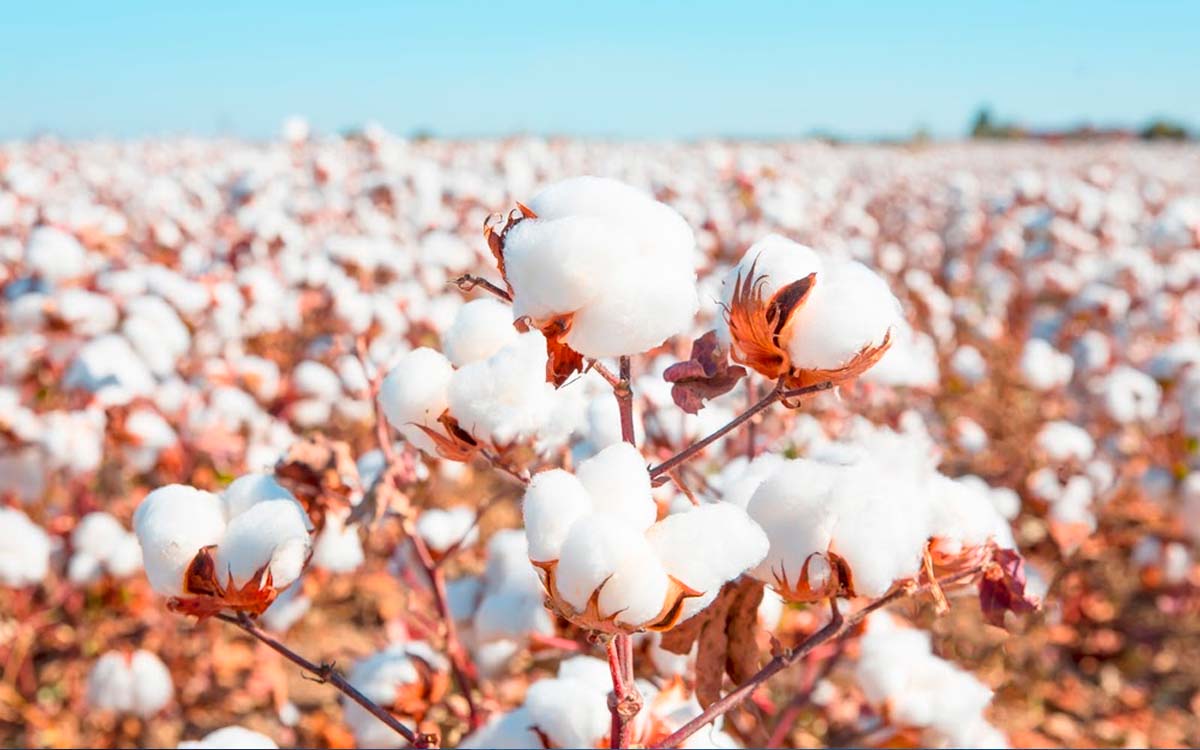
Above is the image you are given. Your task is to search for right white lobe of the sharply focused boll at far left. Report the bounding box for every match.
[216,499,312,589]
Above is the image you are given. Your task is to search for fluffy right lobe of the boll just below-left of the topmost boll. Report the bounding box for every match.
[448,331,554,445]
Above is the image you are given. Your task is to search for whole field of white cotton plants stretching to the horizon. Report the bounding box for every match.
[0,131,1200,748]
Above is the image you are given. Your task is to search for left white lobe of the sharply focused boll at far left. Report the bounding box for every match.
[133,485,226,596]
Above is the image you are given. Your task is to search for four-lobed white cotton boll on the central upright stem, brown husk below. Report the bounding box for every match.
[522,443,766,632]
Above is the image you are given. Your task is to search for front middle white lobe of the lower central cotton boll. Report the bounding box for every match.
[554,514,643,612]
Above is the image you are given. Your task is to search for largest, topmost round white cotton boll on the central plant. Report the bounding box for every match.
[500,176,700,358]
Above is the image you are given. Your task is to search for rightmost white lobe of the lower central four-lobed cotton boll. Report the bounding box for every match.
[646,503,769,619]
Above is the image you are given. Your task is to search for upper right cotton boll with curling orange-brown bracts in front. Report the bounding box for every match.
[722,235,902,380]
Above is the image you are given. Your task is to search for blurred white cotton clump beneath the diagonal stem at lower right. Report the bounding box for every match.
[854,613,1008,748]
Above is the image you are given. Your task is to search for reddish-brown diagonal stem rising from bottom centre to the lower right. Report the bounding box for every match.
[655,565,984,748]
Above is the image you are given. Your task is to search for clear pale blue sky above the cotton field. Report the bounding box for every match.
[0,0,1200,138]
